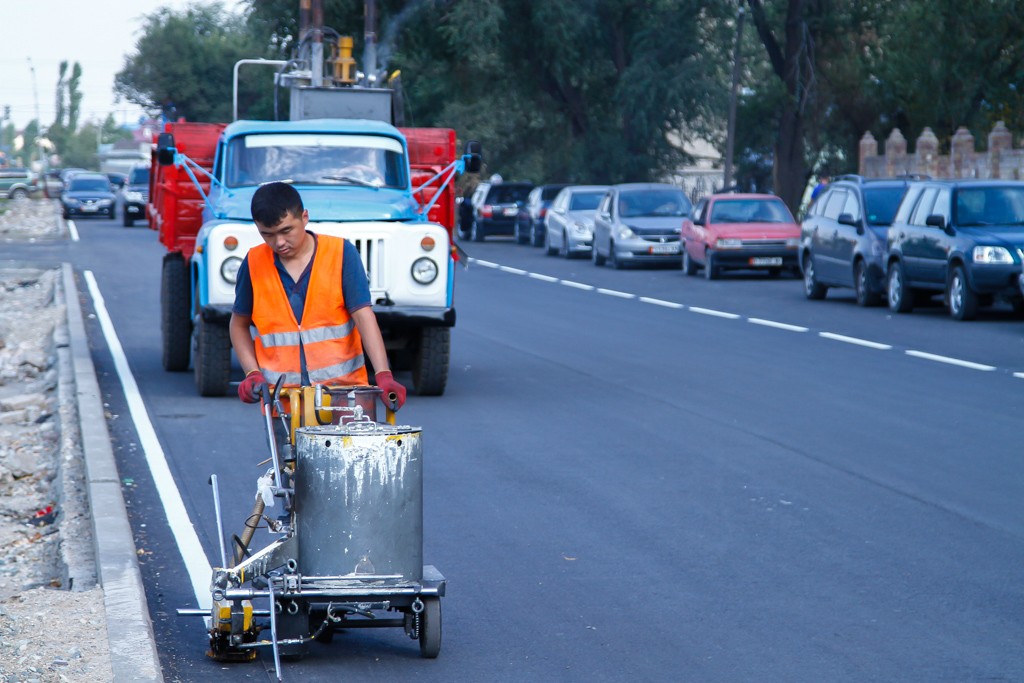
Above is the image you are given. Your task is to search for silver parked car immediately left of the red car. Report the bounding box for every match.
[591,182,692,268]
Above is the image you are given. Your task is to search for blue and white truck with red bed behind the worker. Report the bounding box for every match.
[147,20,480,396]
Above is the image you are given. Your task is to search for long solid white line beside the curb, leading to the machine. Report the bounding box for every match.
[85,270,211,609]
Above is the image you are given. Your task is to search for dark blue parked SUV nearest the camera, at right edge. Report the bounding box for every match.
[886,180,1024,321]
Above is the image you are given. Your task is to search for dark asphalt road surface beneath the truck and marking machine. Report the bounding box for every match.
[0,220,1024,682]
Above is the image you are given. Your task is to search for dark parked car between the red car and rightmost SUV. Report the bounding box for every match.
[800,176,910,306]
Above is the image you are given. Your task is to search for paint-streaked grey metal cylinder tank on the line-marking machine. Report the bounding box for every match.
[294,422,423,583]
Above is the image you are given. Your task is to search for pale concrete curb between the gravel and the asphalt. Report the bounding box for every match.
[61,263,164,682]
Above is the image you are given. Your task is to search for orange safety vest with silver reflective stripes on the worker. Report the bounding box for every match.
[249,234,369,386]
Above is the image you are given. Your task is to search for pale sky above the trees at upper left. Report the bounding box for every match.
[0,0,234,130]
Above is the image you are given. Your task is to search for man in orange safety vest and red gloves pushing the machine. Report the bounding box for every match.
[229,182,406,411]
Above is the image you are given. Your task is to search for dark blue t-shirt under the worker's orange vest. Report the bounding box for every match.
[231,230,372,323]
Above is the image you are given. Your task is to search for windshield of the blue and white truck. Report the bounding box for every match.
[224,133,406,188]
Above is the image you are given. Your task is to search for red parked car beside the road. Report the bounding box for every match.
[683,194,800,280]
